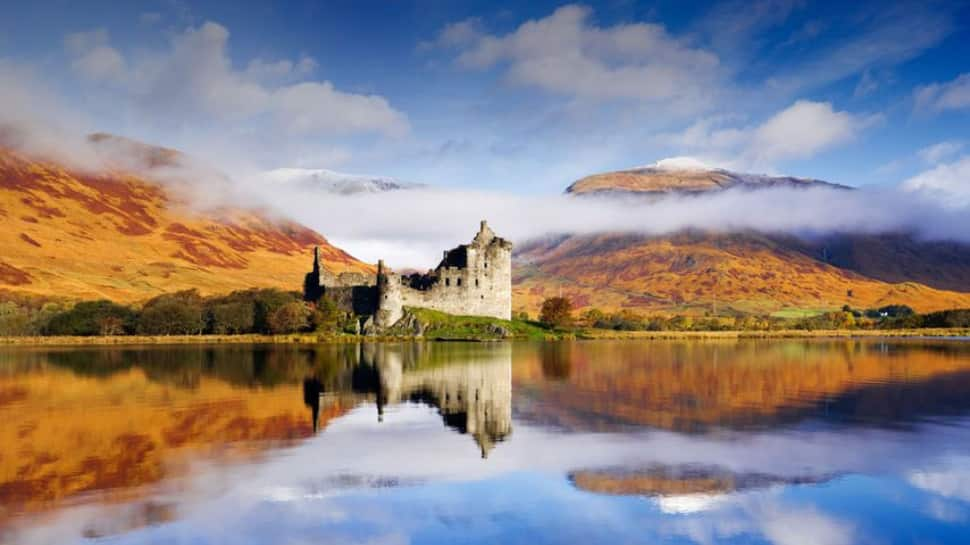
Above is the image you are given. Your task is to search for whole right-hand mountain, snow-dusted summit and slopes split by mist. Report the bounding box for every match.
[513,162,970,313]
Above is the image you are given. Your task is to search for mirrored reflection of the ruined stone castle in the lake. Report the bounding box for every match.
[303,343,512,458]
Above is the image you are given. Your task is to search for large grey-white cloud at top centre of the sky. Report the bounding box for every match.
[439,5,718,107]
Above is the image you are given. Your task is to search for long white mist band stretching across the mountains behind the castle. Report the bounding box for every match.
[0,97,970,269]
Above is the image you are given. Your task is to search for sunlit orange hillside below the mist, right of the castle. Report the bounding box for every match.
[513,232,970,313]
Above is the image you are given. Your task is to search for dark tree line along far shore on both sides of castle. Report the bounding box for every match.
[0,289,970,336]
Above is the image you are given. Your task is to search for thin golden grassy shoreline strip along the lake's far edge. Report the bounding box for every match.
[0,328,970,346]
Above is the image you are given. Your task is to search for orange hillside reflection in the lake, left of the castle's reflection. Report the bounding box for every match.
[0,347,328,520]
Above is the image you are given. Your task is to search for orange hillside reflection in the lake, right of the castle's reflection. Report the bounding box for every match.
[513,340,970,432]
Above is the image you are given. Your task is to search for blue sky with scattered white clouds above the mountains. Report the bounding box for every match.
[0,0,970,194]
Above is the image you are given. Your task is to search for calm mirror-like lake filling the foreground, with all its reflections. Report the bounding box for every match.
[0,340,970,545]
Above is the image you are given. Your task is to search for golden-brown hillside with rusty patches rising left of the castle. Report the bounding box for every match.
[0,144,372,301]
